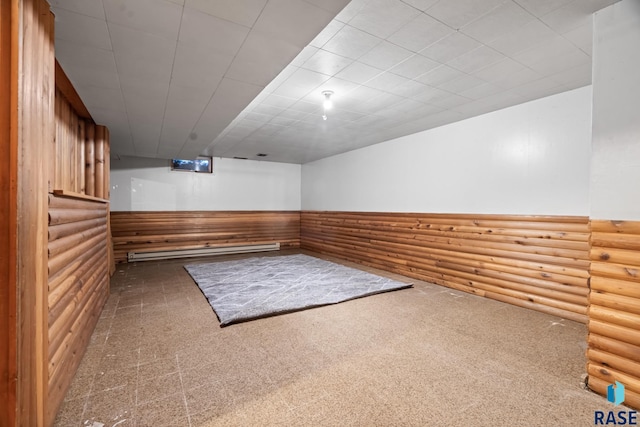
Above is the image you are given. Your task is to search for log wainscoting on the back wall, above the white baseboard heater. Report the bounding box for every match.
[111,211,300,262]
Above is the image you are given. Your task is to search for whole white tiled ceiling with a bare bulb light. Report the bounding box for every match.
[50,0,616,163]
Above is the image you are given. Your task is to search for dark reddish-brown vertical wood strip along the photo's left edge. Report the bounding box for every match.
[0,0,18,426]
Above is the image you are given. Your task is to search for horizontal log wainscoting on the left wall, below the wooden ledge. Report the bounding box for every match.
[47,194,109,424]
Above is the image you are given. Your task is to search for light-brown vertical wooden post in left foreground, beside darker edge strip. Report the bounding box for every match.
[15,0,55,426]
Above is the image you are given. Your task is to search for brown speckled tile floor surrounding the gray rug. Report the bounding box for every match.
[55,249,612,427]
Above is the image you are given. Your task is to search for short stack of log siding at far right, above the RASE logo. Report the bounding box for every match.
[587,220,640,409]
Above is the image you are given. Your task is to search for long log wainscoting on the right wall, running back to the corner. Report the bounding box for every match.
[300,211,589,323]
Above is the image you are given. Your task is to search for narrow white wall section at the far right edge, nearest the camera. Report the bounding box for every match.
[591,0,640,221]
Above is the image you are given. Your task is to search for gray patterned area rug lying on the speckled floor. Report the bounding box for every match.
[184,254,412,326]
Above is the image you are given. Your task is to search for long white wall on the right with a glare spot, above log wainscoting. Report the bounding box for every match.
[302,87,592,215]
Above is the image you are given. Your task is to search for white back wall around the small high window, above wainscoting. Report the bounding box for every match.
[111,157,301,211]
